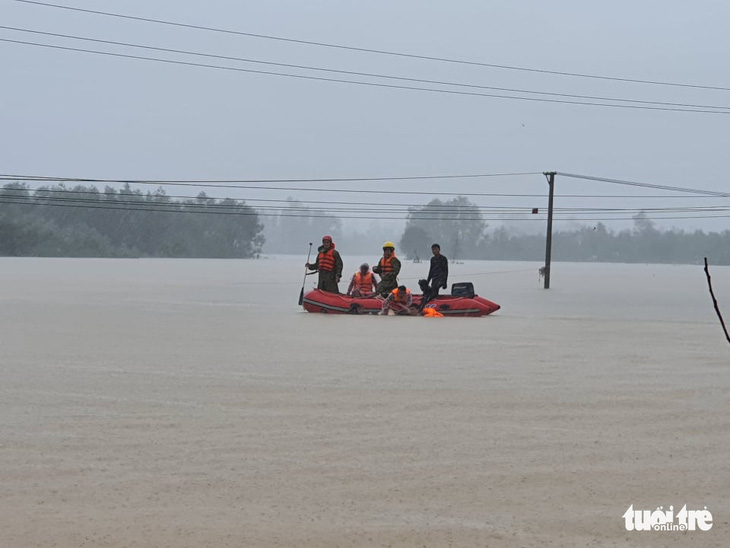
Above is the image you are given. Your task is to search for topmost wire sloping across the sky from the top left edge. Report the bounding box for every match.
[14,0,730,91]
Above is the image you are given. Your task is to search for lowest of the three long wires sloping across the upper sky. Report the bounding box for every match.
[0,38,730,115]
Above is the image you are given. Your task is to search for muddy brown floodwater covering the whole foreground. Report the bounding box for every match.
[0,256,730,548]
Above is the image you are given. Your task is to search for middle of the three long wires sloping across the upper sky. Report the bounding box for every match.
[0,25,730,109]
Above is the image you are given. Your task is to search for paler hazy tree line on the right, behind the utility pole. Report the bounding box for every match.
[400,196,730,265]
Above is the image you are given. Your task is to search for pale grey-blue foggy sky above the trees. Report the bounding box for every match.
[0,0,730,239]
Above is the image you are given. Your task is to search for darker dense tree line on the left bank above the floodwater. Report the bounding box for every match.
[0,183,264,258]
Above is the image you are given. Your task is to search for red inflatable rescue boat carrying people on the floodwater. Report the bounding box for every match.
[302,283,500,316]
